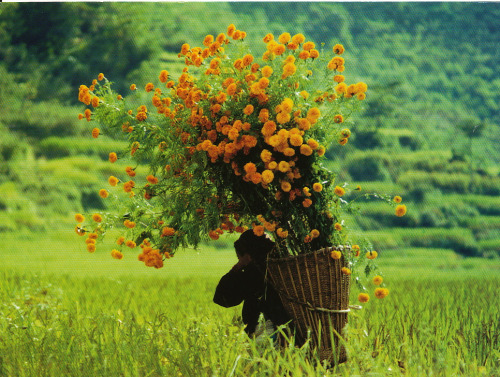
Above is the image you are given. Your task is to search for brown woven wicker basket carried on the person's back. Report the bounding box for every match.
[267,246,350,363]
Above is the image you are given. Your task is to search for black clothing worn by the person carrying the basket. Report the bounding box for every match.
[214,262,290,335]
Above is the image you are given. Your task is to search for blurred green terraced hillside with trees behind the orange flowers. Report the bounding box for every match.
[0,2,500,257]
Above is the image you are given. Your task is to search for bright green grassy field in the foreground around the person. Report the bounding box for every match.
[0,231,500,377]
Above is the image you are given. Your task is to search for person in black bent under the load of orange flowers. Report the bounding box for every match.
[213,230,290,336]
